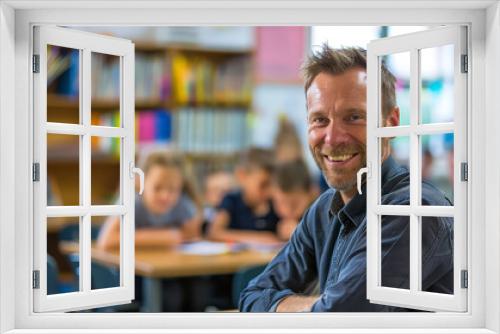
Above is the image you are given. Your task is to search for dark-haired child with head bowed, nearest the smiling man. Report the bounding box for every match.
[272,159,318,241]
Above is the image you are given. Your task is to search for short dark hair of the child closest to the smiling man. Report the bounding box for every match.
[274,159,313,193]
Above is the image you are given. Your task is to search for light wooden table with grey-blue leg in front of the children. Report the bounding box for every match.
[60,243,277,312]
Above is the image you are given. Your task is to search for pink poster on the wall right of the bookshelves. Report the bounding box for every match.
[255,27,307,83]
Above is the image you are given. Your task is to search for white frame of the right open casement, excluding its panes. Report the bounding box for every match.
[366,25,468,312]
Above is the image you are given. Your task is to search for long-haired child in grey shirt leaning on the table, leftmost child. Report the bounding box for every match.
[97,152,202,249]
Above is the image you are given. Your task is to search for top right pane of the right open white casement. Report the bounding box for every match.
[420,45,455,124]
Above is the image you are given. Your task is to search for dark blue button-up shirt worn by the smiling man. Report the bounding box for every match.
[239,157,453,312]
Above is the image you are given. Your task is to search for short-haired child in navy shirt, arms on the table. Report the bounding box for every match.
[207,148,280,244]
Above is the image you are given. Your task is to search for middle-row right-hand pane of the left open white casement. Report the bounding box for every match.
[91,137,122,205]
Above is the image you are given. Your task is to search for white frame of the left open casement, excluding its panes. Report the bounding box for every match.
[33,26,135,312]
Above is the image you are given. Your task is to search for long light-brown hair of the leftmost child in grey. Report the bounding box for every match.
[142,152,201,208]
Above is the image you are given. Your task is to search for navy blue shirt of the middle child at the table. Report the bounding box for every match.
[217,191,279,232]
